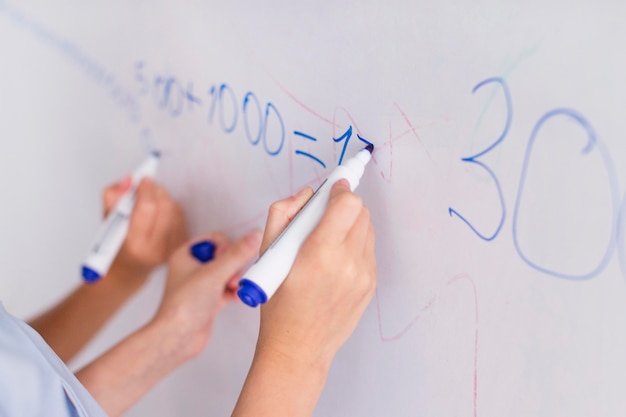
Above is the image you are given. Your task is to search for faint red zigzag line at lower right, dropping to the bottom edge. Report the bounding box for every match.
[376,274,478,417]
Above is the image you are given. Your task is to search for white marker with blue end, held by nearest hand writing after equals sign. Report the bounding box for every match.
[237,144,374,307]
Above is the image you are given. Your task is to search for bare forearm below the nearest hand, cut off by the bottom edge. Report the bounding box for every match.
[232,344,330,417]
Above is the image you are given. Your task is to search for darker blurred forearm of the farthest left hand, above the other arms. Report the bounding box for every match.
[29,264,148,362]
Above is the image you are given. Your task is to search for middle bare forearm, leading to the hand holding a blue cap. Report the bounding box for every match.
[76,316,192,417]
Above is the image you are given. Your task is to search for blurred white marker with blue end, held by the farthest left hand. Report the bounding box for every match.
[82,152,160,282]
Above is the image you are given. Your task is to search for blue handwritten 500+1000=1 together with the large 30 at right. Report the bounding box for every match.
[135,61,626,280]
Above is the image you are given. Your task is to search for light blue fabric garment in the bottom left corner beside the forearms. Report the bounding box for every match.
[0,303,106,417]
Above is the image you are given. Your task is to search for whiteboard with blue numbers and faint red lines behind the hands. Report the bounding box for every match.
[0,0,626,417]
